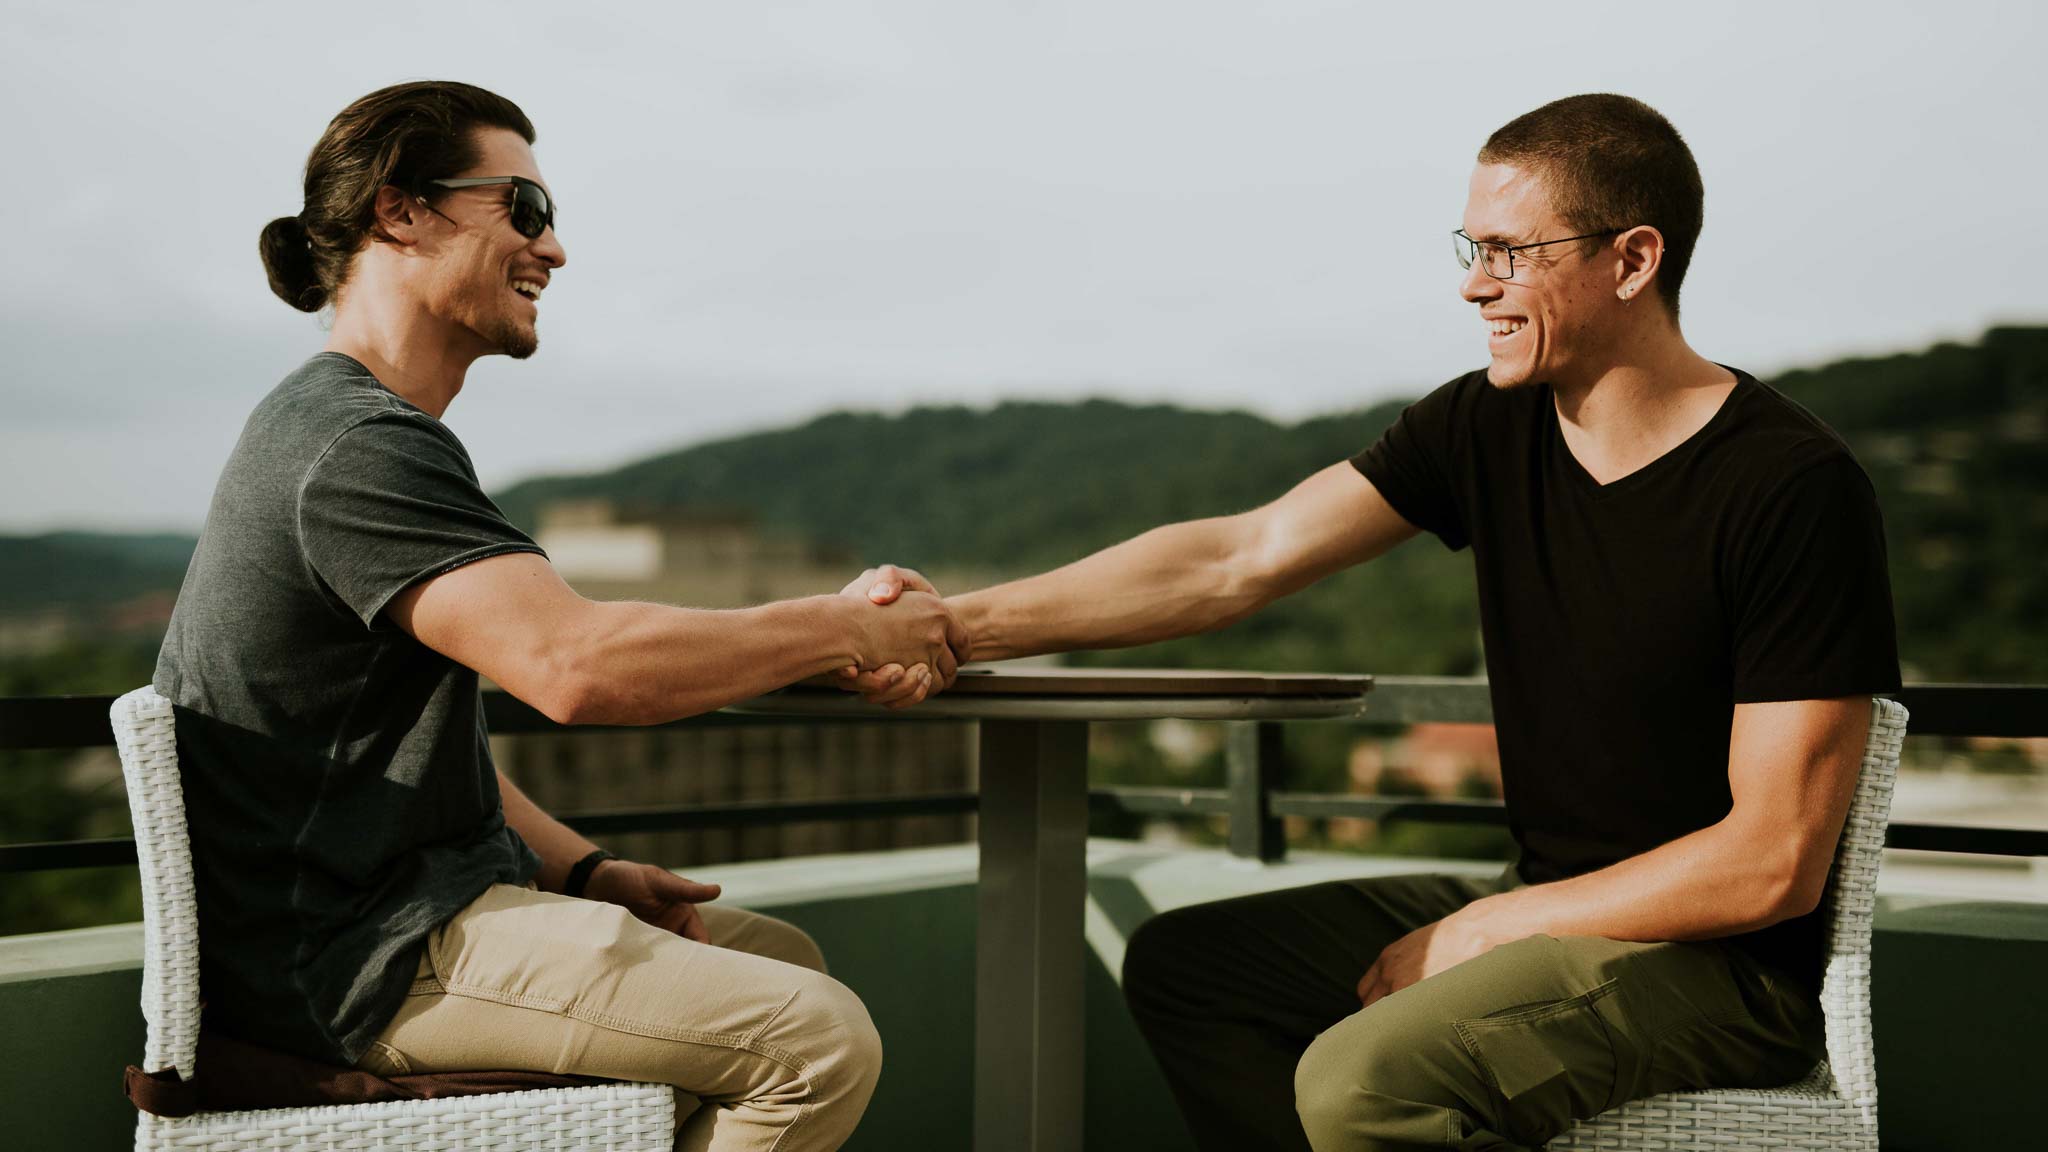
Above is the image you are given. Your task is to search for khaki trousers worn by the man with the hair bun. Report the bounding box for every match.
[358,883,881,1152]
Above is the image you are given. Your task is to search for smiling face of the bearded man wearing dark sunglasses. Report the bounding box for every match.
[418,129,567,359]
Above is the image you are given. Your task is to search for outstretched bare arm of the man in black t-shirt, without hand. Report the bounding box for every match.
[948,463,1417,660]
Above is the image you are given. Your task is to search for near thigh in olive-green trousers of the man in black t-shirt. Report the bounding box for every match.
[1296,937,1819,1146]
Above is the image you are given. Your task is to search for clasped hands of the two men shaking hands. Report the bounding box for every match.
[825,564,973,707]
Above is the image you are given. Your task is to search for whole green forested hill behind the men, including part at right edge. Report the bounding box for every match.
[500,328,2048,681]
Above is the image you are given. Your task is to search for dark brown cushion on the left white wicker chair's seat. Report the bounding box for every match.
[123,1033,606,1117]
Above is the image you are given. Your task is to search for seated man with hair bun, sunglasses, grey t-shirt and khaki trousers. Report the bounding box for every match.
[156,82,967,1152]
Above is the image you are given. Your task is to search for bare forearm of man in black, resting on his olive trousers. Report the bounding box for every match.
[1458,824,1806,945]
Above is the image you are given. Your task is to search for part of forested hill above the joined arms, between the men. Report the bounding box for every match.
[500,400,1401,568]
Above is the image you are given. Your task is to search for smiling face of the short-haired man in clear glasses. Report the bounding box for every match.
[1458,164,1622,387]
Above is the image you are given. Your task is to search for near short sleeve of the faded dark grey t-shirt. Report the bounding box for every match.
[299,412,541,627]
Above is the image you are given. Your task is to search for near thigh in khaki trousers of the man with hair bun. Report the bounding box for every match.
[377,886,879,1101]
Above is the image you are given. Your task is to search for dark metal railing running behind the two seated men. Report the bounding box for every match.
[0,676,2048,873]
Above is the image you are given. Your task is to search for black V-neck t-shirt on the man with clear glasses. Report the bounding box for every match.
[1352,371,1898,988]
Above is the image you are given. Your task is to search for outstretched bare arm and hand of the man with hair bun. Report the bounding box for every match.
[387,553,967,724]
